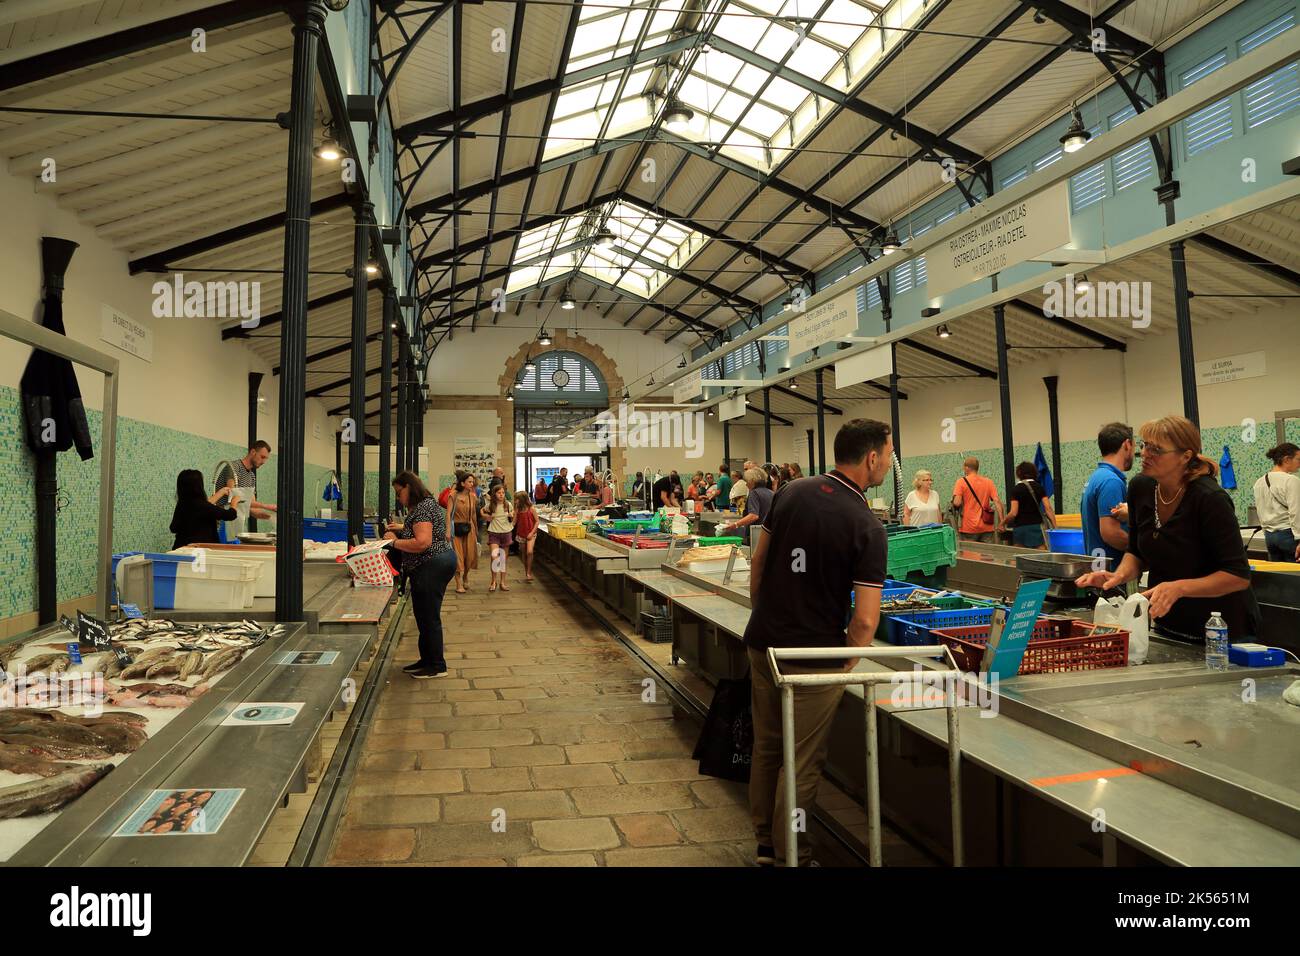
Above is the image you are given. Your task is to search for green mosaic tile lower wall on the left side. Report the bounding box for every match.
[0,386,343,619]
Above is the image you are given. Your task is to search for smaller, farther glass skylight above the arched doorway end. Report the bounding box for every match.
[506,202,705,299]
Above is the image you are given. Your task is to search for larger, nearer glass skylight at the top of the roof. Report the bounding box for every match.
[545,0,923,170]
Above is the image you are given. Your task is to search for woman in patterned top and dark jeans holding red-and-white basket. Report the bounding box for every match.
[384,471,456,680]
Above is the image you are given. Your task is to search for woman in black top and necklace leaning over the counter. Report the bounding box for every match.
[1075,415,1260,640]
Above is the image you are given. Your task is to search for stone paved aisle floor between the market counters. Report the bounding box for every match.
[322,558,753,866]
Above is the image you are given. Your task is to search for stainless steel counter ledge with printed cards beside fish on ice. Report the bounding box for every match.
[9,618,363,866]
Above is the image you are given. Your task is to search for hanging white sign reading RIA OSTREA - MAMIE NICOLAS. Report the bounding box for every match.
[926,181,1070,295]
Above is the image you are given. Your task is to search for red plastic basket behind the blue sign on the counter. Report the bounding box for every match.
[932,618,1128,674]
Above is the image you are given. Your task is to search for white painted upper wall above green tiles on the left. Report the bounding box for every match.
[0,172,335,470]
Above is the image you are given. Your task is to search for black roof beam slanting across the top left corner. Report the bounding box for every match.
[0,0,289,92]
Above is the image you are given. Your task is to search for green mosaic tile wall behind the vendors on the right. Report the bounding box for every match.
[870,420,1300,524]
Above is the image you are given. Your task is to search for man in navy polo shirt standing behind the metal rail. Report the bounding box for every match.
[745,419,893,866]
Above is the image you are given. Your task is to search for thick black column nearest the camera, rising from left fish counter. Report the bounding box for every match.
[276,0,326,620]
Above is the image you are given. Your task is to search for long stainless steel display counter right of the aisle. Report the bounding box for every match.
[535,530,1300,866]
